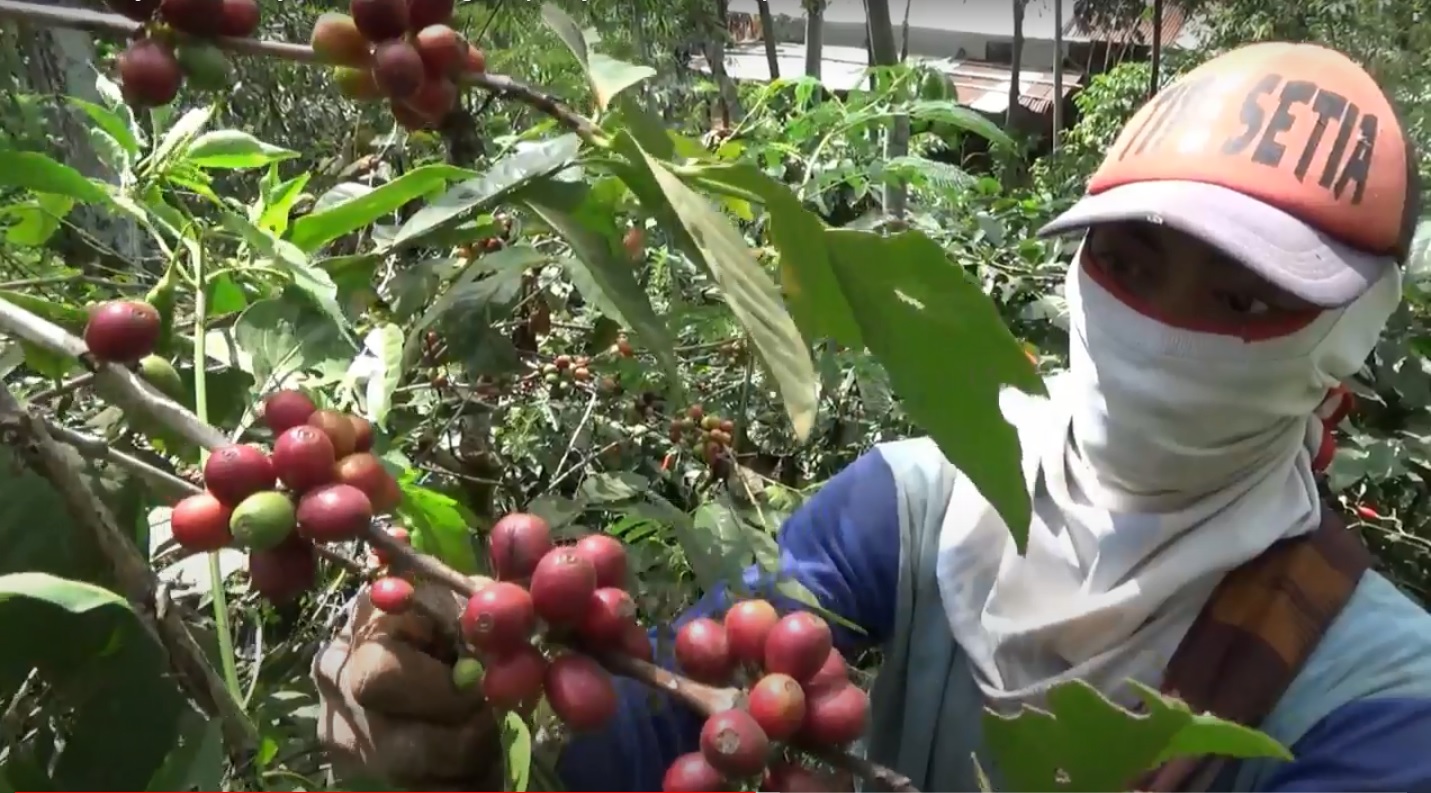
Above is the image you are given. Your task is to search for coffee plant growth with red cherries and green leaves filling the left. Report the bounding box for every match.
[8,0,1419,790]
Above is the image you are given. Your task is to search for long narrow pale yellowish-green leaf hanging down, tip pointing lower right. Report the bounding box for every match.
[622,136,819,439]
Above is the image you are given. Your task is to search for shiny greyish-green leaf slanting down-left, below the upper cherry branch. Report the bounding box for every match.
[388,135,581,248]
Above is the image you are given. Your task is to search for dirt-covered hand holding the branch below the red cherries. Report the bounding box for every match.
[313,575,501,790]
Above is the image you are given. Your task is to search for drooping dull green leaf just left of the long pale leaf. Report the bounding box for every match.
[517,182,683,397]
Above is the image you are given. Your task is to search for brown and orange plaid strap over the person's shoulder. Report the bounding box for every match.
[1130,508,1371,793]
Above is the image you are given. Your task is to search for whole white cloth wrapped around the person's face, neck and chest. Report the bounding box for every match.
[936,249,1401,703]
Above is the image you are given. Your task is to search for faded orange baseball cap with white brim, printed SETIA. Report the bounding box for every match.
[1039,43,1421,308]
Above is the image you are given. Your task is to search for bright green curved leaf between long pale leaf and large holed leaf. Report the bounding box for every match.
[700,163,864,348]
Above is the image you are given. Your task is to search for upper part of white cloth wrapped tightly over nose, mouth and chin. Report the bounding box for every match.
[1066,256,1400,504]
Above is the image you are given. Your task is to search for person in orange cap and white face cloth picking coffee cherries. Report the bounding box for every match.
[315,44,1431,790]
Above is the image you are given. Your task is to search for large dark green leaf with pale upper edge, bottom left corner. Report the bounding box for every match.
[0,573,187,790]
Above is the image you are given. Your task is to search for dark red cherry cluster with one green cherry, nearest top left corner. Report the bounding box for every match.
[109,0,260,107]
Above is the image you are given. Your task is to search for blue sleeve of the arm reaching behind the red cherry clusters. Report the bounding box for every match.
[558,449,900,790]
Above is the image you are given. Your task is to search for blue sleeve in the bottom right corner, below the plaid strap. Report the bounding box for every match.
[1265,697,1431,793]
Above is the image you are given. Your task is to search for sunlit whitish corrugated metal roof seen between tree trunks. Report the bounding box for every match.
[691,42,1083,113]
